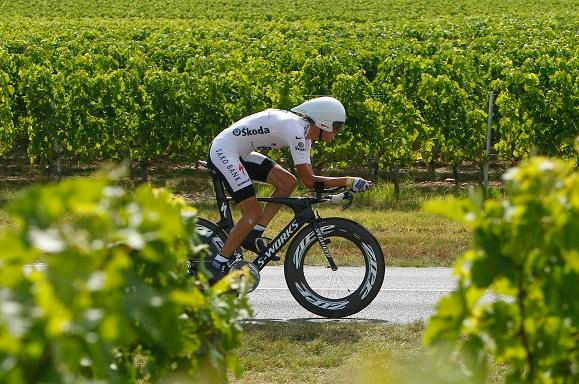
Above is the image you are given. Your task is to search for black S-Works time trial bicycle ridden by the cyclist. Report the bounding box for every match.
[189,161,385,318]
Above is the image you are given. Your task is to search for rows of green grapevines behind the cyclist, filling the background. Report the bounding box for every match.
[0,0,579,178]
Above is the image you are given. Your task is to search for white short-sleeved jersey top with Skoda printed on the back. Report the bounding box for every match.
[214,109,312,165]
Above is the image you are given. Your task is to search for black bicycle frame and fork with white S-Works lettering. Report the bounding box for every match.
[209,168,337,270]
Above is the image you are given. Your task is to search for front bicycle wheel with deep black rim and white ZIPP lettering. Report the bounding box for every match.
[284,218,385,318]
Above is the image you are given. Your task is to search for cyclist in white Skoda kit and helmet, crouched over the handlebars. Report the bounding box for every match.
[208,97,371,283]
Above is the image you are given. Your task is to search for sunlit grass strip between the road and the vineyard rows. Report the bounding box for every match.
[0,178,472,267]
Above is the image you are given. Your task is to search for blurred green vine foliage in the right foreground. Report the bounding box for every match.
[424,157,579,383]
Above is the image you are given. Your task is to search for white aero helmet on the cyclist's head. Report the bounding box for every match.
[291,96,346,132]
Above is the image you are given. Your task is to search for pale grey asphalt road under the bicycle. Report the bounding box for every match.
[249,266,456,324]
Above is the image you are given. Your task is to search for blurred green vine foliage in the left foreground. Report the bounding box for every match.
[0,171,249,383]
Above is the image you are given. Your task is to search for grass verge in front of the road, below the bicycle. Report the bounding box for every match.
[230,321,508,384]
